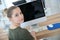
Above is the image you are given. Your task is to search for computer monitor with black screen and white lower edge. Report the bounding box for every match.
[12,0,46,27]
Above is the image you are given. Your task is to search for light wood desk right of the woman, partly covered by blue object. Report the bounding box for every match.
[36,13,60,39]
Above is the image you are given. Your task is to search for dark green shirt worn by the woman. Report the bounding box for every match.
[9,27,34,40]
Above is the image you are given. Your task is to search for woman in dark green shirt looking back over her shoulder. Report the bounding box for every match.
[7,6,35,40]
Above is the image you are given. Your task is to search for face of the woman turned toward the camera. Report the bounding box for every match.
[11,8,24,24]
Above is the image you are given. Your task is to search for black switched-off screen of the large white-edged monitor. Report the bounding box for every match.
[18,0,45,22]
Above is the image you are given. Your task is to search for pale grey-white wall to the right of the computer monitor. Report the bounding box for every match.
[45,0,60,16]
